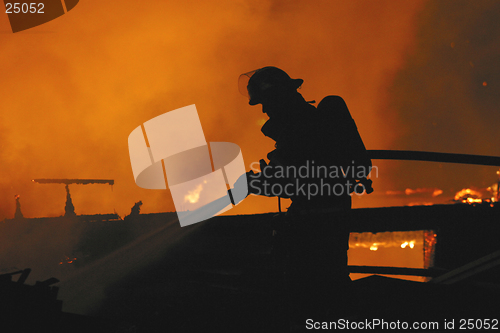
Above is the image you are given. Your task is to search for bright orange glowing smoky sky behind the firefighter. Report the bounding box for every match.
[0,0,496,220]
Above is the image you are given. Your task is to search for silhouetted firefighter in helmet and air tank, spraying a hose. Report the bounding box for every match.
[235,67,373,323]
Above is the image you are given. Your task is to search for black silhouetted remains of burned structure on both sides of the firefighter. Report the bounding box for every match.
[0,204,500,333]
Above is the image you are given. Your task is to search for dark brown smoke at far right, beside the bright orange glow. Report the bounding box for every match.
[390,1,500,196]
